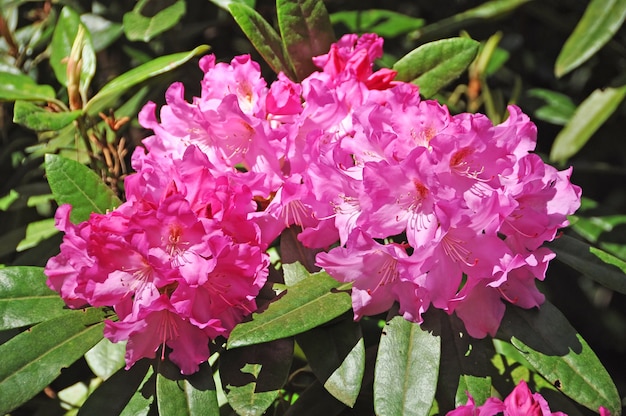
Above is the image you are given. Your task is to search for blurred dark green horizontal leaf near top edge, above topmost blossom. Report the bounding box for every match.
[330,9,424,39]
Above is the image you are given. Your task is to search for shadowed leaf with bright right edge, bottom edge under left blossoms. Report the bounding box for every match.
[77,359,154,416]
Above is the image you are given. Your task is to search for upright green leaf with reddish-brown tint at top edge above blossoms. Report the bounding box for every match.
[276,0,335,80]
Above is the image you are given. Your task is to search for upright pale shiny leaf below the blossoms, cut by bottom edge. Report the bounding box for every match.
[374,316,441,416]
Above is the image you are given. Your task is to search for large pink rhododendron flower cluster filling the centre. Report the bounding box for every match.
[46,34,580,373]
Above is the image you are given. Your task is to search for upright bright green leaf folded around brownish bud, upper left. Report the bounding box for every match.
[50,6,96,98]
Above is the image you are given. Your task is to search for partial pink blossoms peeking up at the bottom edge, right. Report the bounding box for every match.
[446,380,564,416]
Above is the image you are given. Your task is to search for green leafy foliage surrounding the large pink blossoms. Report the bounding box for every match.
[0,0,626,415]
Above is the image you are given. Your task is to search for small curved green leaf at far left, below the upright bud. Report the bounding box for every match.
[13,100,83,131]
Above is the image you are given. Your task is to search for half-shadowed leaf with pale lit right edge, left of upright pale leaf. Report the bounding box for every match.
[296,319,365,407]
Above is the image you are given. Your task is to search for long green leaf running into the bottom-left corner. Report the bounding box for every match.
[0,308,104,414]
